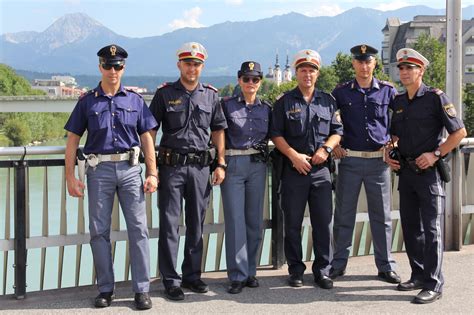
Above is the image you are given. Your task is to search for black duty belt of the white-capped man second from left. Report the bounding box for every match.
[156,148,213,166]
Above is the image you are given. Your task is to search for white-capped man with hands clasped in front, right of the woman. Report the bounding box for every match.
[270,49,342,289]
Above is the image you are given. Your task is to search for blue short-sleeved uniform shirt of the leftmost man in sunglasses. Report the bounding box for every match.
[64,84,157,154]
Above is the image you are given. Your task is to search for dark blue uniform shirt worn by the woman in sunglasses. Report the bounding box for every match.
[222,94,272,150]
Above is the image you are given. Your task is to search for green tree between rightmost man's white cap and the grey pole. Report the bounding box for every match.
[413,34,446,90]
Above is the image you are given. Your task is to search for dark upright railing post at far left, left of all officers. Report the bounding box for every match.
[13,159,27,299]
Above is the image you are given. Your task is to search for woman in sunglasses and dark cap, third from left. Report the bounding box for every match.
[221,61,271,294]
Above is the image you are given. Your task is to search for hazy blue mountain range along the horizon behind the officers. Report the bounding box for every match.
[0,5,474,76]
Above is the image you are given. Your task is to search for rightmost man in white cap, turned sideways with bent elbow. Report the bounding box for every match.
[386,48,466,304]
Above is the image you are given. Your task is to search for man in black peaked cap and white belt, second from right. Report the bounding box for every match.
[329,44,400,283]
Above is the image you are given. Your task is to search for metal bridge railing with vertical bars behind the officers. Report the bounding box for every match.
[0,138,474,298]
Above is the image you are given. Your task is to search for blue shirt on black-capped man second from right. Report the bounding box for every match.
[332,78,397,151]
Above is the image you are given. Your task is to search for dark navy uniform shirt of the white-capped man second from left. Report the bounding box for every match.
[150,80,227,153]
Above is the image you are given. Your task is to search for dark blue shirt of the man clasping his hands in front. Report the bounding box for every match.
[270,87,342,155]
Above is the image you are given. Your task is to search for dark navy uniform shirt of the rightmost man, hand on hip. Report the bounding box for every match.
[390,83,464,158]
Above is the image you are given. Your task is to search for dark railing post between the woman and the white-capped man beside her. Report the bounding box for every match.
[270,167,285,269]
